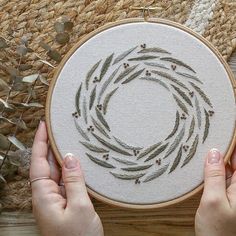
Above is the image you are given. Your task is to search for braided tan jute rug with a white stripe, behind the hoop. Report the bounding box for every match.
[0,0,236,144]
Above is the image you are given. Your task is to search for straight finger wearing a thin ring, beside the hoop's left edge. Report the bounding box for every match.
[30,121,58,198]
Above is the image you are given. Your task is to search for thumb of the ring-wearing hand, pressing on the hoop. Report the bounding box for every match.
[62,153,91,208]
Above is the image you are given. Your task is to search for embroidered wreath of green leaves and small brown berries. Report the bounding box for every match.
[72,43,214,184]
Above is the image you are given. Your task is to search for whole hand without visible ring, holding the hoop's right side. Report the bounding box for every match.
[195,148,236,236]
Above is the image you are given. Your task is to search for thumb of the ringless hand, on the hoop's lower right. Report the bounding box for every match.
[202,149,227,202]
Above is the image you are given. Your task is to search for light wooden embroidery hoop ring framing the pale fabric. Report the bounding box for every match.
[45,18,236,210]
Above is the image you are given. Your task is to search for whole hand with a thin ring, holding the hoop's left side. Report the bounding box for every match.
[30,122,103,236]
